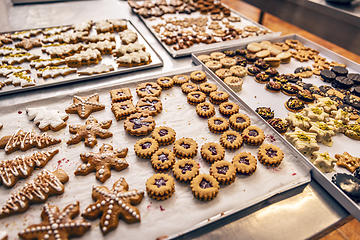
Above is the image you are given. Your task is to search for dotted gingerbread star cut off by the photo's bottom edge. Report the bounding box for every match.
[19,201,91,240]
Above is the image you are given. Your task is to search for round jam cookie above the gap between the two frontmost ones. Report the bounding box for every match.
[172,158,199,183]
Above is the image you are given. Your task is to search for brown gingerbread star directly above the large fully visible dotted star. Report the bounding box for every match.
[74,143,129,183]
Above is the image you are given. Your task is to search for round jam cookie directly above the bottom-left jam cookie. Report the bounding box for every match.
[151,148,175,172]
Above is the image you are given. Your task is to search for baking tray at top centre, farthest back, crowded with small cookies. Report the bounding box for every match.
[138,3,281,58]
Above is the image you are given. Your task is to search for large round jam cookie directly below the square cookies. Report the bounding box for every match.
[124,112,155,136]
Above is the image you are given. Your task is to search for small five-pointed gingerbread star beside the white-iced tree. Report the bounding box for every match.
[65,93,105,119]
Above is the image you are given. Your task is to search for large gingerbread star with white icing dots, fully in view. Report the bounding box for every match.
[81,178,144,235]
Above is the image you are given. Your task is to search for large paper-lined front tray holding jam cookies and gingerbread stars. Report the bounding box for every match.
[0,66,311,239]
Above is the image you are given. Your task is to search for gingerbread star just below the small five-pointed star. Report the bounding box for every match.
[66,116,113,147]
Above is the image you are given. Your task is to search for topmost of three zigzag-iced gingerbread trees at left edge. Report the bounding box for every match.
[0,129,61,154]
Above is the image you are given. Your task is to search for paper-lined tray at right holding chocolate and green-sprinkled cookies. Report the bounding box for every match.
[192,34,360,221]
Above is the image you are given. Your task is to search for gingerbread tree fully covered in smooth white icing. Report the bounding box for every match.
[26,107,69,131]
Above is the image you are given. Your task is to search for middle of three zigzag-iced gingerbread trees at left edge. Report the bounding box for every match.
[0,149,59,188]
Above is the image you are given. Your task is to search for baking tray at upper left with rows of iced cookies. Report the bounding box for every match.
[0,20,164,96]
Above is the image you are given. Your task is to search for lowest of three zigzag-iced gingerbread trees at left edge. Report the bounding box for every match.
[0,169,69,219]
